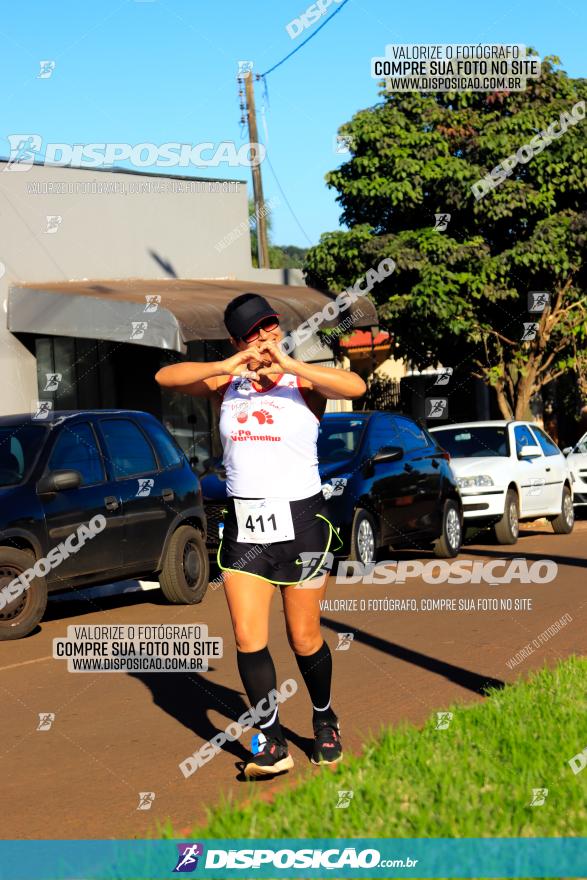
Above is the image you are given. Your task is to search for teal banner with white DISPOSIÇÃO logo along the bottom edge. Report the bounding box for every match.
[0,837,587,880]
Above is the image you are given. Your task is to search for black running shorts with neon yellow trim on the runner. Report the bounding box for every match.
[217,492,342,586]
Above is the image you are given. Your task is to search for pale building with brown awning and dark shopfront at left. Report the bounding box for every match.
[0,161,377,462]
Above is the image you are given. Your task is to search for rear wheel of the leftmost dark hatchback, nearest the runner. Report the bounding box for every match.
[159,526,210,605]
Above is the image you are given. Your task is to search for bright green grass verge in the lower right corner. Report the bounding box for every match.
[159,657,587,840]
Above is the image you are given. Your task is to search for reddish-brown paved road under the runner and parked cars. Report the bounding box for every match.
[0,522,587,838]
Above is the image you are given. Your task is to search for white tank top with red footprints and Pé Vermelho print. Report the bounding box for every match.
[219,373,321,501]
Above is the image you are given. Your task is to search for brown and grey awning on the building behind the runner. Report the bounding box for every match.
[7,278,378,353]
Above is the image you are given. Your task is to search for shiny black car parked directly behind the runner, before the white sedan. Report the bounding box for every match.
[202,412,463,563]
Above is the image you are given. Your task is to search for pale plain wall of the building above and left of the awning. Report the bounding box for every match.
[0,161,253,415]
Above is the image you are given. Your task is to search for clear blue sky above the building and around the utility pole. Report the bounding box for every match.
[0,0,587,245]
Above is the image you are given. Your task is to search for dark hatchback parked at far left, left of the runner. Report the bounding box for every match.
[0,409,209,639]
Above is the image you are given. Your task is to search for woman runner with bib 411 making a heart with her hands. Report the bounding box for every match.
[155,293,366,776]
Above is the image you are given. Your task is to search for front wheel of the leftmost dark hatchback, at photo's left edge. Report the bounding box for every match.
[0,547,47,641]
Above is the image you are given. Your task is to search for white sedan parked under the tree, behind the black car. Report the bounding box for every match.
[430,421,575,544]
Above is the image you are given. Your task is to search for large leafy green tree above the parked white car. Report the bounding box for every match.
[305,57,587,418]
